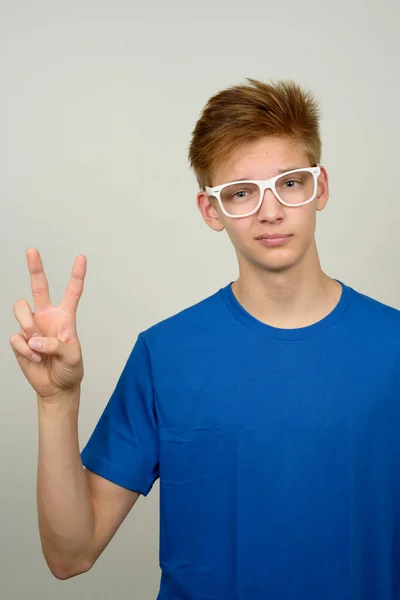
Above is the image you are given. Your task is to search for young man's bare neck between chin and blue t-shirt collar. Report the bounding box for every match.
[232,244,342,329]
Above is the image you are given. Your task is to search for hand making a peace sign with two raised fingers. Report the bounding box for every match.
[10,248,86,401]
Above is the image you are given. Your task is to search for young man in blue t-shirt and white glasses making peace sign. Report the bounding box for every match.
[12,80,400,600]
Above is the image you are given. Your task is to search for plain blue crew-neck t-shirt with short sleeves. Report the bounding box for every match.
[82,282,400,600]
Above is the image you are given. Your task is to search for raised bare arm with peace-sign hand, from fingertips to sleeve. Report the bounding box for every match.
[10,248,139,579]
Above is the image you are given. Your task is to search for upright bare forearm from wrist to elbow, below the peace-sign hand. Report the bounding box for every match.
[37,392,94,578]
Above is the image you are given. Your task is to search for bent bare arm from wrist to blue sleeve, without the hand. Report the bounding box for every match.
[37,392,140,579]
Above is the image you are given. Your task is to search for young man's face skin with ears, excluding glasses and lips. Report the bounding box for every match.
[197,136,329,274]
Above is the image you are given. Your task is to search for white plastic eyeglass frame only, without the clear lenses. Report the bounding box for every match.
[204,165,321,219]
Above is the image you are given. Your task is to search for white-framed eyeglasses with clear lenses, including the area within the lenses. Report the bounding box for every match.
[205,166,321,219]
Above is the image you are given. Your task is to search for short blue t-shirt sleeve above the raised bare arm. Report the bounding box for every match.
[81,334,159,496]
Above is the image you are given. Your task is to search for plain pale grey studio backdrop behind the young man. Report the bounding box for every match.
[0,0,400,600]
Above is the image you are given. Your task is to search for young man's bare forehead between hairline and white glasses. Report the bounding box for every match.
[212,136,310,186]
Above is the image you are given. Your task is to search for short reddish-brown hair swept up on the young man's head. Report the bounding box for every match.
[189,77,321,190]
